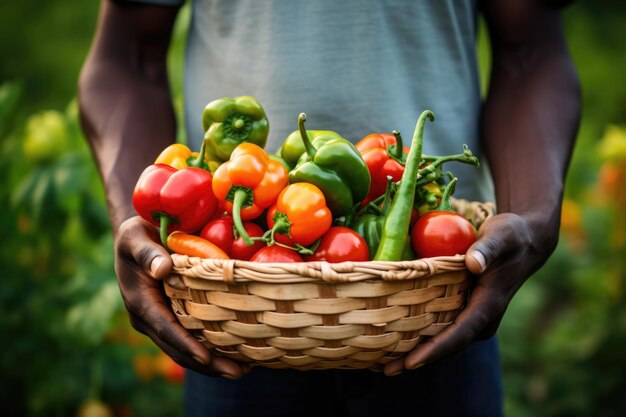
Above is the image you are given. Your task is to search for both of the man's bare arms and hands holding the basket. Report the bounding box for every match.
[79,0,580,379]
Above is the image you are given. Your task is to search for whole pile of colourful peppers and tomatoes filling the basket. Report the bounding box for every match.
[132,96,479,262]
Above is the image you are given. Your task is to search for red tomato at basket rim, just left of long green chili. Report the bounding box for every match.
[304,226,369,262]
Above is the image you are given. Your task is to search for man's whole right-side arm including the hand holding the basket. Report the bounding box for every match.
[385,0,580,375]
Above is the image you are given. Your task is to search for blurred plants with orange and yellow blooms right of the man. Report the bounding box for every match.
[500,126,626,417]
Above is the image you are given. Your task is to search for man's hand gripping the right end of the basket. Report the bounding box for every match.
[384,213,558,375]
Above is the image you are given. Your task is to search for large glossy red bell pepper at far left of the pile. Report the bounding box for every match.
[132,164,218,247]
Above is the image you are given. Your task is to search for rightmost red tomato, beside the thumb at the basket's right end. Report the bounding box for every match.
[411,211,476,258]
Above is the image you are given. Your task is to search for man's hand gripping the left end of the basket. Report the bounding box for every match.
[115,217,249,379]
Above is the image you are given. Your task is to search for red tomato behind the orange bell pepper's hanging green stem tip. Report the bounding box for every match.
[200,216,265,261]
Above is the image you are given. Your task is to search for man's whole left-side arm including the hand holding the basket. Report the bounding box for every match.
[78,0,243,378]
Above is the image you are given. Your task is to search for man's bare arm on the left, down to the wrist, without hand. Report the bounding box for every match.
[78,1,177,231]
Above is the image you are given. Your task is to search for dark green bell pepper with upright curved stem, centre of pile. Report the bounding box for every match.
[289,113,371,217]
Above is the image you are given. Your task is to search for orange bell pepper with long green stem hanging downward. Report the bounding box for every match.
[213,142,288,246]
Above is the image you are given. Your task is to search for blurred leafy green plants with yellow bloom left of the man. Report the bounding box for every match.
[0,84,182,417]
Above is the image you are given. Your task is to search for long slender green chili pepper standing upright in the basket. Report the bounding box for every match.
[374,110,435,261]
